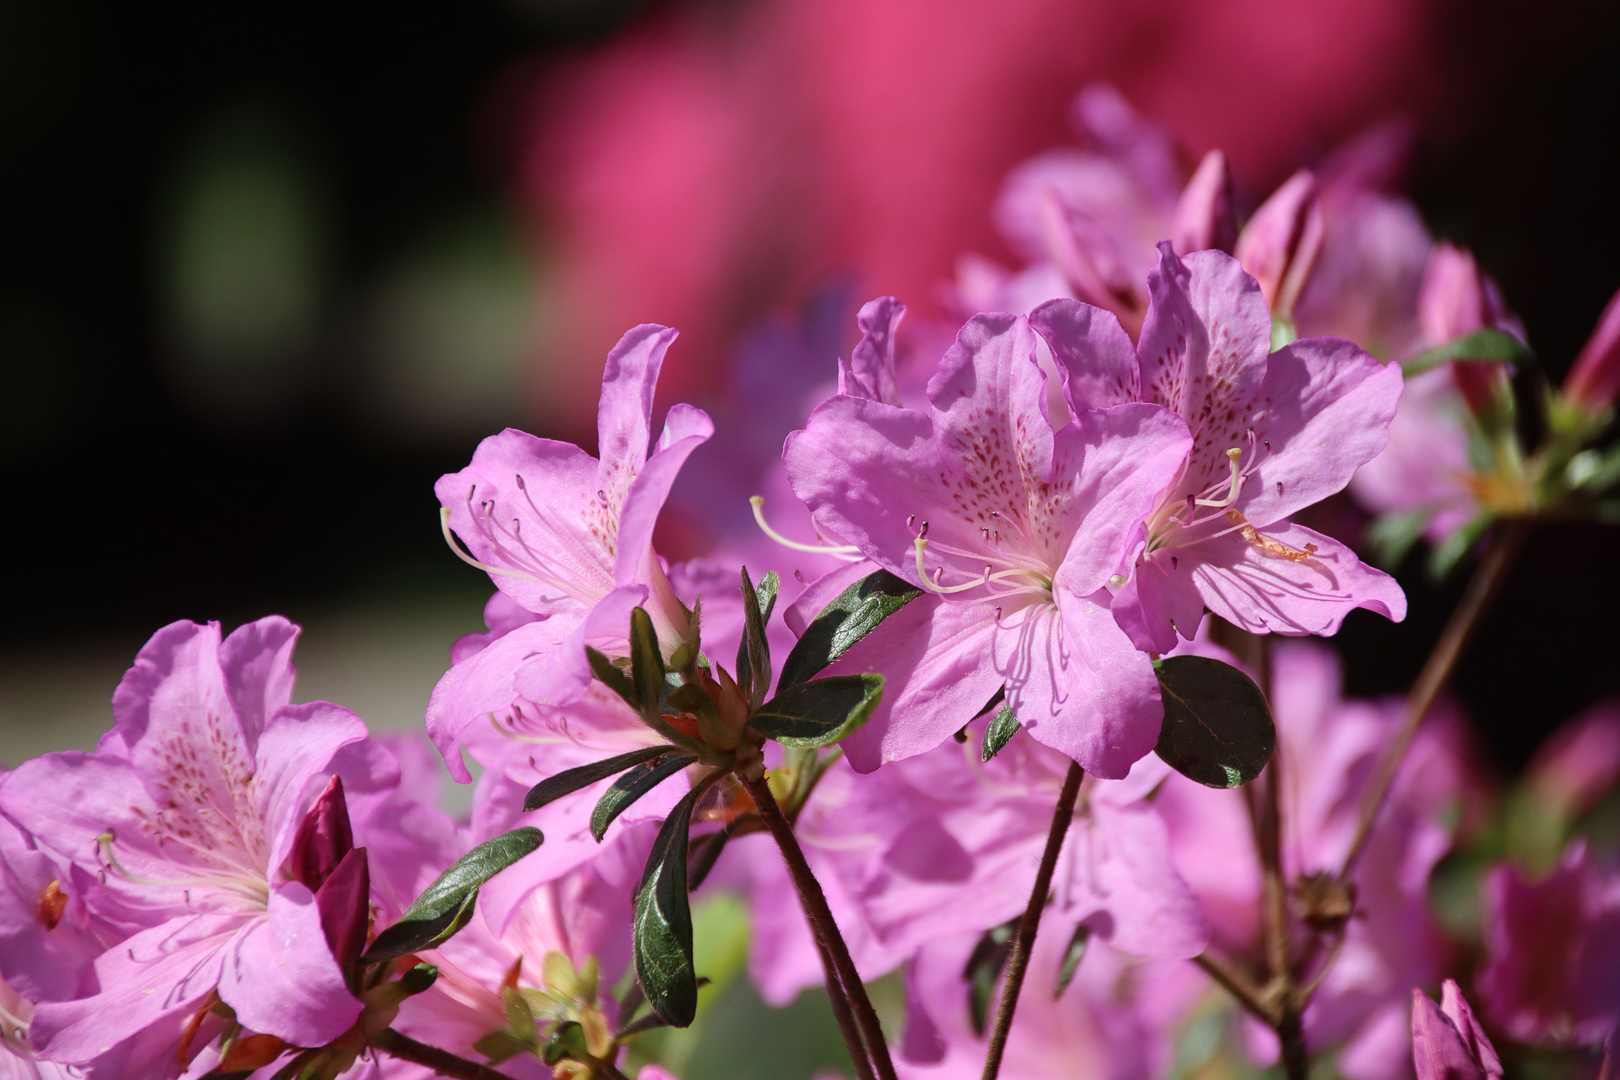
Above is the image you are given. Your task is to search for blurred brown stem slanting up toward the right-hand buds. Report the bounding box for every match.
[1338,520,1529,881]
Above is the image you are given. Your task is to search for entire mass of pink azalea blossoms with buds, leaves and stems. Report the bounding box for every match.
[0,80,1620,1080]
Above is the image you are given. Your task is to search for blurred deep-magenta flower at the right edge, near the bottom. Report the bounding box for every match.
[1477,842,1620,1044]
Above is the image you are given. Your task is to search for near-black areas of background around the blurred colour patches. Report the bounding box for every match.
[0,0,1620,767]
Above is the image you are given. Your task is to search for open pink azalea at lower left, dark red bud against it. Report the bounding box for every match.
[0,617,397,1075]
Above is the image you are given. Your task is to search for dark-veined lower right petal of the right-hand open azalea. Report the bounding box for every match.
[1179,523,1406,635]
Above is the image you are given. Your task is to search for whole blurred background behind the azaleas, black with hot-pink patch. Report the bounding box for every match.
[0,0,1620,1078]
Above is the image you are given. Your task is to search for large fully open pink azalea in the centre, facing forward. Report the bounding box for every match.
[786,307,1187,777]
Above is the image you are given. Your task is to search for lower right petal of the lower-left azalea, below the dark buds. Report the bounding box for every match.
[219,881,360,1046]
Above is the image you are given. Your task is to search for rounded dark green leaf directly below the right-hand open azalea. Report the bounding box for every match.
[1153,656,1277,787]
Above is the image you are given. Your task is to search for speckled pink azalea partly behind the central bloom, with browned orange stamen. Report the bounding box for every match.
[1030,243,1406,653]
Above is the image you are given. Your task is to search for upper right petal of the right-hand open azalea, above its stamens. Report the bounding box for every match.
[1231,337,1403,528]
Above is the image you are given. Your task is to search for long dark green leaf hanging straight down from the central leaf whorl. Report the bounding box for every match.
[632,787,706,1028]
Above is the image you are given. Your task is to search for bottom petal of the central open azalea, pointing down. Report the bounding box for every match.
[1017,591,1165,779]
